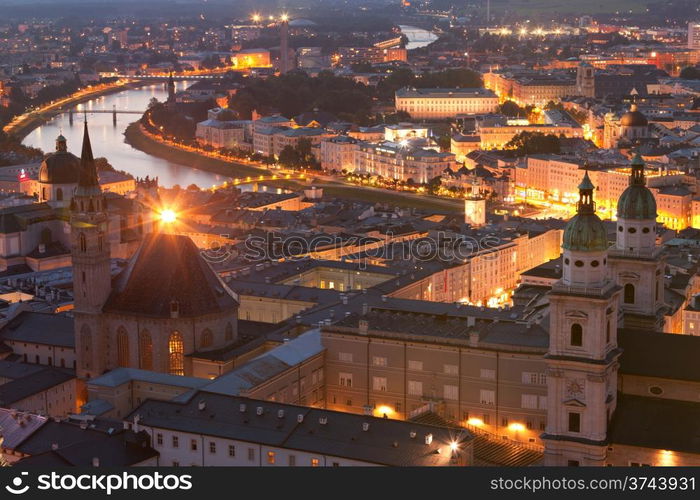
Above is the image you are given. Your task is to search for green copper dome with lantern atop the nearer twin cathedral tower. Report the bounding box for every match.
[562,172,608,252]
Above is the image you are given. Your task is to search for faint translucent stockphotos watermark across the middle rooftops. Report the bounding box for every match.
[202,231,503,264]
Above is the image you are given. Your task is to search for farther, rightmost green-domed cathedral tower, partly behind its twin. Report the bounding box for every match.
[610,154,665,330]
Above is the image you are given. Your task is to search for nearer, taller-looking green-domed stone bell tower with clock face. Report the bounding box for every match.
[542,172,621,465]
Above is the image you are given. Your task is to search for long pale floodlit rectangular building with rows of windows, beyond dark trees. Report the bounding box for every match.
[395,87,498,120]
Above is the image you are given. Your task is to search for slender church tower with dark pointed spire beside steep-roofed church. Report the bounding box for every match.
[70,121,111,378]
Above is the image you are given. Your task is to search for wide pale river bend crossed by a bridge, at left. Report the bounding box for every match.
[23,82,228,187]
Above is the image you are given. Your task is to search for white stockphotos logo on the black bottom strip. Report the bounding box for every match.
[5,471,192,495]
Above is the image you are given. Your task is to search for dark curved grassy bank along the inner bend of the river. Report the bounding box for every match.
[124,122,271,181]
